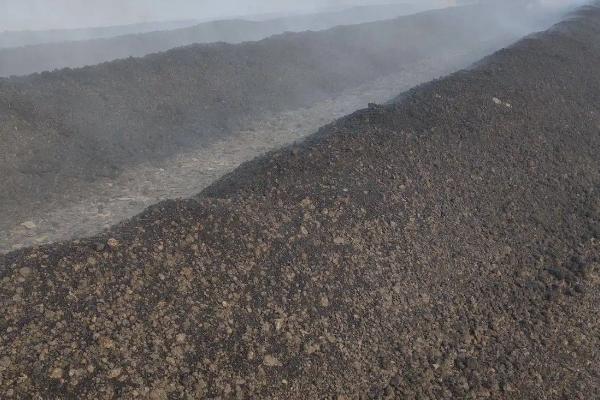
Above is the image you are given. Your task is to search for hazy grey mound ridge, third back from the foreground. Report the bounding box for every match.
[0,4,416,77]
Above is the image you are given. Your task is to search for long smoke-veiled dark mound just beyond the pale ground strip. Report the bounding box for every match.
[0,3,544,231]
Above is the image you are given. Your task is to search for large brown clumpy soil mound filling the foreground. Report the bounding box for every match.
[0,3,600,399]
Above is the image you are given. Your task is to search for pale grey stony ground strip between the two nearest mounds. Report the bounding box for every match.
[0,56,462,252]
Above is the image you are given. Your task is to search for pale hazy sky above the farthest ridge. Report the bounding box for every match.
[0,0,453,31]
